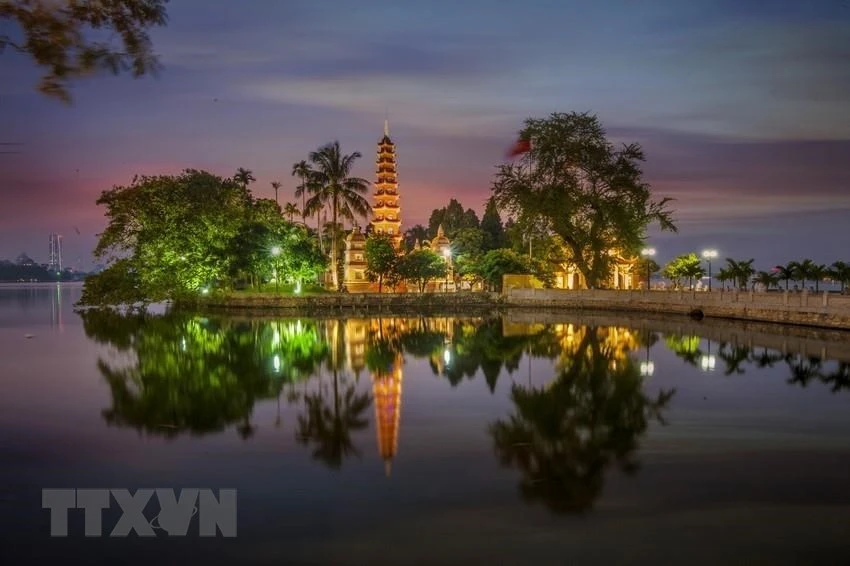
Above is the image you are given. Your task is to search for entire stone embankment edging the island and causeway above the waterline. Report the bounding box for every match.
[183,289,850,330]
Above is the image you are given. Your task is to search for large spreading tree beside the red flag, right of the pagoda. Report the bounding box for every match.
[493,113,676,288]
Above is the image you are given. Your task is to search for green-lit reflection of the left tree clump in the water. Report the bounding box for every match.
[82,310,327,437]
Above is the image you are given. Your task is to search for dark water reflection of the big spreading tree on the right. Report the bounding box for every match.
[490,328,674,513]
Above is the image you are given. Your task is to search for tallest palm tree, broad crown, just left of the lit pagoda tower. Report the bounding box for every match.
[305,141,372,290]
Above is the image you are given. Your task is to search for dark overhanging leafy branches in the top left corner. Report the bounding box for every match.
[0,0,168,103]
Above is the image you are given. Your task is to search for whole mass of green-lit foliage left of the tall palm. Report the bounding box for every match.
[82,169,326,305]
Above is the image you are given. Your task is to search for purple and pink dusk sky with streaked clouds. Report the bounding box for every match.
[0,0,850,269]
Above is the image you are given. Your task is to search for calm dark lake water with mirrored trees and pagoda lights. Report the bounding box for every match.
[0,285,850,565]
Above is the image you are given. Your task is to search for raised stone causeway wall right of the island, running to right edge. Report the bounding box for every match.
[505,289,850,329]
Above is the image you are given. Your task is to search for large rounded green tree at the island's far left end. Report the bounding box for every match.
[86,169,252,303]
